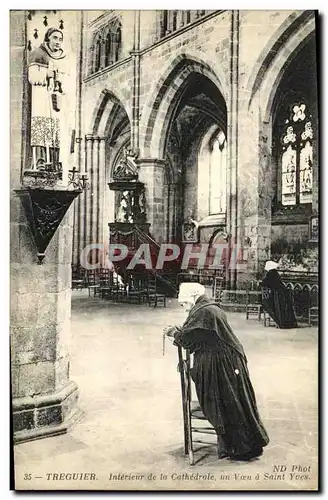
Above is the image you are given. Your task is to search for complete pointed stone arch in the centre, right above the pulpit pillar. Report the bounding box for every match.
[140,53,227,159]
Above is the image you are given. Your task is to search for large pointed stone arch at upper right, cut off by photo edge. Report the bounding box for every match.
[247,11,315,123]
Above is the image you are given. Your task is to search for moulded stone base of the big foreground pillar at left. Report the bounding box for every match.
[12,382,83,444]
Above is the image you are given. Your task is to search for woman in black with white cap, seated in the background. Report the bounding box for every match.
[262,260,297,328]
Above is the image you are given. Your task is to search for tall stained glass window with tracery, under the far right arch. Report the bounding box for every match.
[281,102,313,205]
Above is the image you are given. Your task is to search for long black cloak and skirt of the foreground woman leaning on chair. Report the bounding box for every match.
[174,295,269,457]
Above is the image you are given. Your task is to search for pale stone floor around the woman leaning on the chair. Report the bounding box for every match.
[15,291,318,491]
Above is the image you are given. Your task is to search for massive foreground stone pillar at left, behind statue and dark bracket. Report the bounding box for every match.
[10,11,81,442]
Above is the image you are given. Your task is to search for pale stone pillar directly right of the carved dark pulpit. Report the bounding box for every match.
[137,158,166,243]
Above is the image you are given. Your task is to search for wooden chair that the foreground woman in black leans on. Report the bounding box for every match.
[178,346,217,465]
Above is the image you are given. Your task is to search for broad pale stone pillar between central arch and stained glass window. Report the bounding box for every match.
[237,91,272,288]
